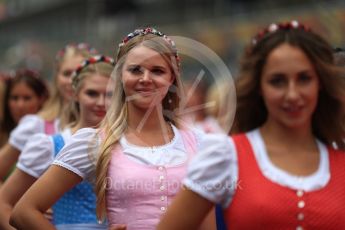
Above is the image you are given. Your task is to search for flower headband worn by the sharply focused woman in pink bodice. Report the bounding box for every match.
[117,27,180,67]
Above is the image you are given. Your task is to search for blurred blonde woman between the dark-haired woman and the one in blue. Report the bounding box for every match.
[0,43,93,185]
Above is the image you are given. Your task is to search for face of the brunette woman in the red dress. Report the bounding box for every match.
[260,43,320,128]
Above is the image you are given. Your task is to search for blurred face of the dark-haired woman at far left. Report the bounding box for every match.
[8,82,43,123]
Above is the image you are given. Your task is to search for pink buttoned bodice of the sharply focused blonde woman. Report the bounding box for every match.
[106,131,196,230]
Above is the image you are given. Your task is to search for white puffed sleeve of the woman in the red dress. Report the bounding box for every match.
[183,134,238,208]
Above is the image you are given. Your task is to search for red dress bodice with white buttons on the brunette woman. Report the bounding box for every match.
[225,134,345,230]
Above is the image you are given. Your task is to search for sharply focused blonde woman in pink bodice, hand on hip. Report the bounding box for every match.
[12,28,212,229]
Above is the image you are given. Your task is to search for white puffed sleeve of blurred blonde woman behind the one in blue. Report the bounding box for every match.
[9,115,44,151]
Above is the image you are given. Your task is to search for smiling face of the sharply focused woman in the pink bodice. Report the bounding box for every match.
[122,45,174,110]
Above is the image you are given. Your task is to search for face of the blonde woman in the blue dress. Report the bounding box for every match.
[76,73,109,127]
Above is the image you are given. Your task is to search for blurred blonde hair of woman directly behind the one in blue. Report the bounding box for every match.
[39,43,93,128]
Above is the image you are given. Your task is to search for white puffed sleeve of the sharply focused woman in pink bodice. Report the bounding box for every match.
[53,128,100,182]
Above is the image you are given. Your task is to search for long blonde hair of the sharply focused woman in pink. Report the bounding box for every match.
[95,29,182,220]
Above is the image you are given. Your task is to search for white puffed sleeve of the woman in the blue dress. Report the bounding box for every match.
[17,133,54,178]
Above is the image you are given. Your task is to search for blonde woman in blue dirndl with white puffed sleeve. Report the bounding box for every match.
[0,56,114,230]
